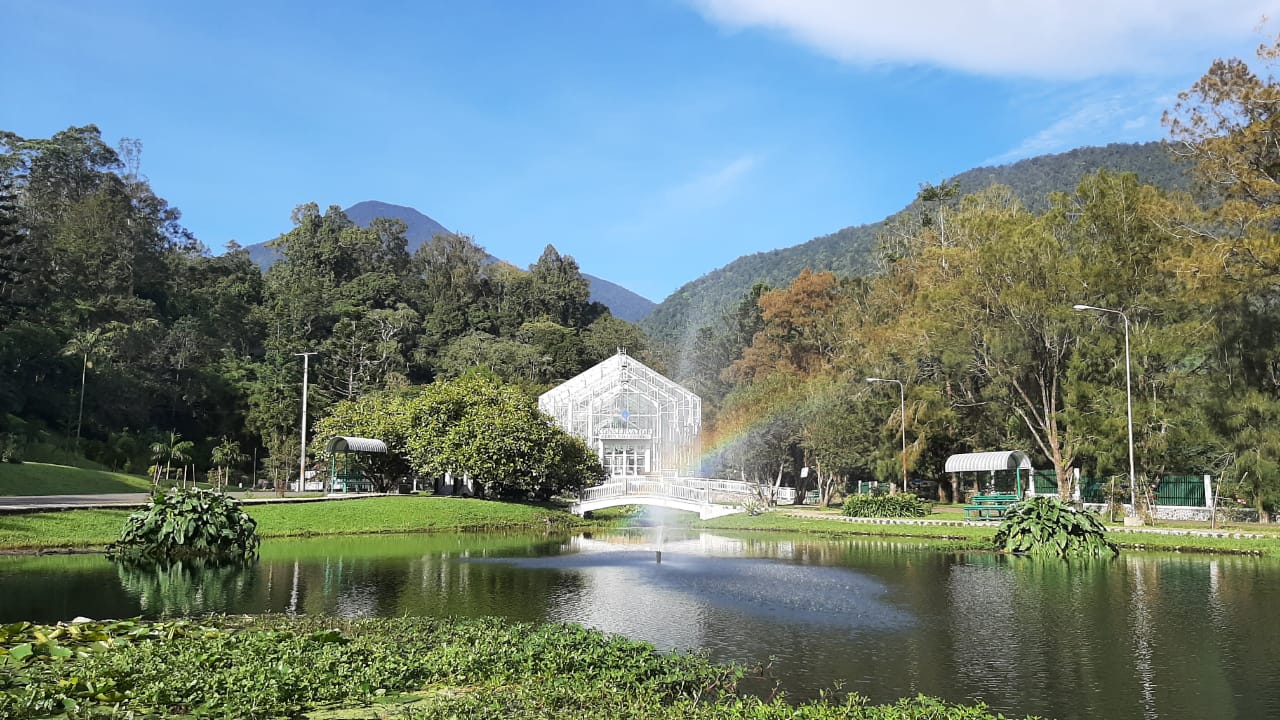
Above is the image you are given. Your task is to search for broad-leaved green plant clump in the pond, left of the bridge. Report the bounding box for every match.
[108,488,259,561]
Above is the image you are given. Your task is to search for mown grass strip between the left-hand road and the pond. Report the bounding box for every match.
[0,496,584,551]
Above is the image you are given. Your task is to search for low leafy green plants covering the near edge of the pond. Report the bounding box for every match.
[0,616,1018,720]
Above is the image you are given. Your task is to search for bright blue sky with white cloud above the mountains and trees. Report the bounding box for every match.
[0,0,1275,301]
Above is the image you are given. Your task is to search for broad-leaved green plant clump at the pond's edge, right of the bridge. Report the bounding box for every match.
[992,497,1120,557]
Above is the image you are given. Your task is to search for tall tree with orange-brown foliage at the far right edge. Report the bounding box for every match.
[1165,38,1280,511]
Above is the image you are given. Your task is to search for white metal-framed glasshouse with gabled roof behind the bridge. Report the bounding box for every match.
[538,350,703,477]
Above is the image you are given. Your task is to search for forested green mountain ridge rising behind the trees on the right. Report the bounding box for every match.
[640,142,1192,343]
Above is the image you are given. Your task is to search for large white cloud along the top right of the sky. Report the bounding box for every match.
[687,0,1275,78]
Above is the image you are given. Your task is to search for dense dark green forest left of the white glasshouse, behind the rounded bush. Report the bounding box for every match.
[0,126,645,474]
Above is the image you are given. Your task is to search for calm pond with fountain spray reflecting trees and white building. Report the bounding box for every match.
[0,529,1280,719]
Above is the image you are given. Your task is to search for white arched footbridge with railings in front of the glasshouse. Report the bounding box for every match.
[570,475,795,520]
